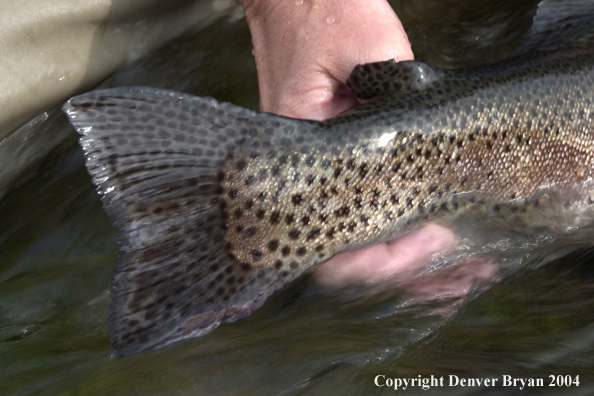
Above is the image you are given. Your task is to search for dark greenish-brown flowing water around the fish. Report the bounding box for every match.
[0,0,594,396]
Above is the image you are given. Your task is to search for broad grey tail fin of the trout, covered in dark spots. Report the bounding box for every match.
[63,88,308,356]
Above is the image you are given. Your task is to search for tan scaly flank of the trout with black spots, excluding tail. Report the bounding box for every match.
[220,55,594,270]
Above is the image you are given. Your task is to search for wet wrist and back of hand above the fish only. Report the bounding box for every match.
[236,0,414,120]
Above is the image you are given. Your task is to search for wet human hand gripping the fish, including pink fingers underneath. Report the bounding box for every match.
[238,0,455,286]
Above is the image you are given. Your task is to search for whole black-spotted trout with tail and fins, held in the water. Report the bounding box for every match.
[63,0,594,356]
